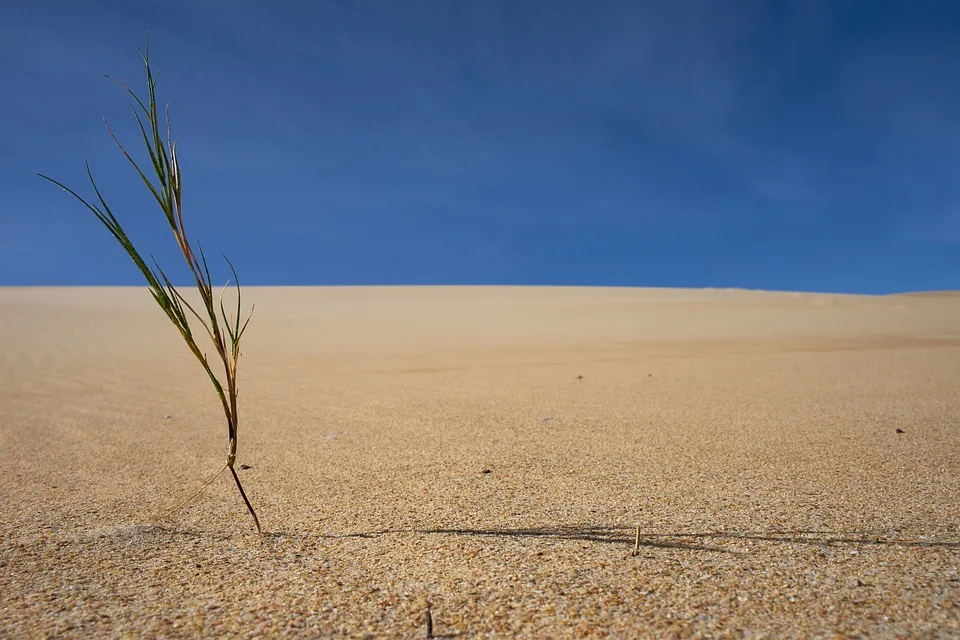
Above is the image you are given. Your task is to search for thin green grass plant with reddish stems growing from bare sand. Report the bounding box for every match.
[39,37,262,534]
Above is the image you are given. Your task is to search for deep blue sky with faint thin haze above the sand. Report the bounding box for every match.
[0,0,960,293]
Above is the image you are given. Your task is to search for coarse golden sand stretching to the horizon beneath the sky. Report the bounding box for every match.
[0,287,960,638]
